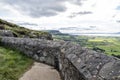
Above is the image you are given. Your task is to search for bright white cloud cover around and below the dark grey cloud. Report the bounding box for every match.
[0,0,120,32]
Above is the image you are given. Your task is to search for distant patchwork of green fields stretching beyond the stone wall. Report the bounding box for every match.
[53,35,120,56]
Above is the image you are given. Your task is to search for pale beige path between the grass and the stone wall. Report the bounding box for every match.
[19,62,61,80]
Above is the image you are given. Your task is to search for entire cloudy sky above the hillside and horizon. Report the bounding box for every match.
[0,0,120,33]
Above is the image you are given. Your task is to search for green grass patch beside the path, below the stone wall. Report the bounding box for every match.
[0,46,33,80]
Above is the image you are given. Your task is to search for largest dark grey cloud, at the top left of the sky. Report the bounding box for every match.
[2,0,67,17]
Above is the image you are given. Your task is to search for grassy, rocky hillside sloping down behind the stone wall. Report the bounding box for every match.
[0,19,52,40]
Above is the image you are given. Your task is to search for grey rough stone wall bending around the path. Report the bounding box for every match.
[1,37,120,80]
